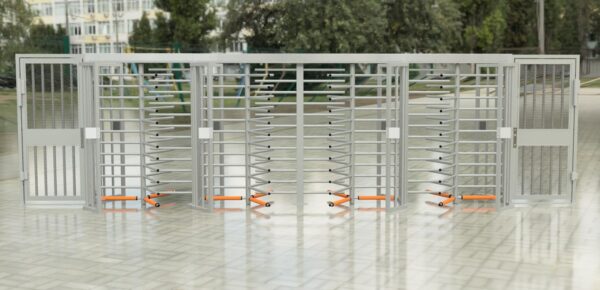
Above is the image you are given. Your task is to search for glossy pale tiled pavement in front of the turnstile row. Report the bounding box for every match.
[0,90,600,289]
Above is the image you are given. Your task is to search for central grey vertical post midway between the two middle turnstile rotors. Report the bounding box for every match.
[296,63,304,213]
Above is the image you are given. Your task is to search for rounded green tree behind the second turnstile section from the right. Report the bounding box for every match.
[385,0,462,52]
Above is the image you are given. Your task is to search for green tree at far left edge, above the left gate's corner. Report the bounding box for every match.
[0,0,34,75]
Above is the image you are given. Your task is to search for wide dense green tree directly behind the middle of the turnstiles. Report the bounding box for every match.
[276,0,386,53]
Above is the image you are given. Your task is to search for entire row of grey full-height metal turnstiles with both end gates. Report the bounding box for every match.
[17,54,579,210]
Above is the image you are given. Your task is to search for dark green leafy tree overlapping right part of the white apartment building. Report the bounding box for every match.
[156,0,216,52]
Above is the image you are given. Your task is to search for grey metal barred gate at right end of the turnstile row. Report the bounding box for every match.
[511,58,578,203]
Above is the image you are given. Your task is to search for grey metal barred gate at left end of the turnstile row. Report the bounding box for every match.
[17,57,83,205]
